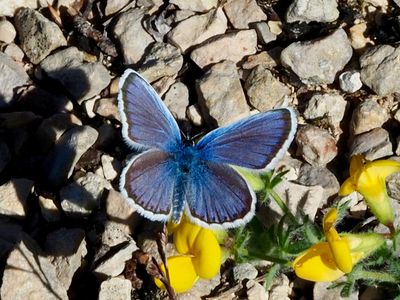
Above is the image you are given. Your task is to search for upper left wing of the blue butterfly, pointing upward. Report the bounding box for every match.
[118,69,181,151]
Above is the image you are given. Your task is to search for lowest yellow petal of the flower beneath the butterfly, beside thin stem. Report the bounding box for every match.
[154,255,198,293]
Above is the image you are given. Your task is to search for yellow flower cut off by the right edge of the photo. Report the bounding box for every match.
[339,155,400,227]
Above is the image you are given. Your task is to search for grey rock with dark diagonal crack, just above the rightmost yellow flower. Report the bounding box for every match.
[350,128,393,160]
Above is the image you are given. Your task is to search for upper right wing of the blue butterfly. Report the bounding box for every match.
[196,108,297,170]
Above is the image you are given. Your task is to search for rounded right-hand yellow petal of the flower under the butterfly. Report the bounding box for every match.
[192,228,221,279]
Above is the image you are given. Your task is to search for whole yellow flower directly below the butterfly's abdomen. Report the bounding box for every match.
[155,218,221,293]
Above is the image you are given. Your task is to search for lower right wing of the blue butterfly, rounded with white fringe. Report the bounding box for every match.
[186,162,256,228]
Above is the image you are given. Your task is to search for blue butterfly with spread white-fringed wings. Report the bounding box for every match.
[118,69,297,229]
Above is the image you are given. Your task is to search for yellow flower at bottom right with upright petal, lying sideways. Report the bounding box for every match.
[292,208,384,282]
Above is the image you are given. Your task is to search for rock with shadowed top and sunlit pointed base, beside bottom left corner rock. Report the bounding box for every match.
[45,228,87,290]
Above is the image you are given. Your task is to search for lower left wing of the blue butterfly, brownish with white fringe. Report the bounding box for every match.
[120,149,176,222]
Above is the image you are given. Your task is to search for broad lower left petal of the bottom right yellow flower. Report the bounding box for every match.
[292,242,344,282]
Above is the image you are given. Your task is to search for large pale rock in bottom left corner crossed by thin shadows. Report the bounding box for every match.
[0,236,68,300]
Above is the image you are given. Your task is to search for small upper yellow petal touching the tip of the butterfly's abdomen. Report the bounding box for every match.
[173,218,202,254]
